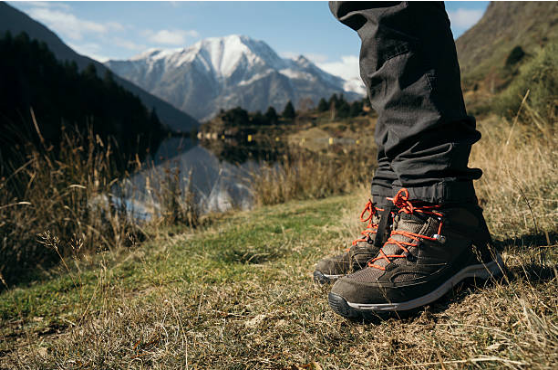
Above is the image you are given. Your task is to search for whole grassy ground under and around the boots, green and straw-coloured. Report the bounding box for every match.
[0,111,558,369]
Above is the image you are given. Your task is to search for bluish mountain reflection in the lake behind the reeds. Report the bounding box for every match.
[121,137,258,219]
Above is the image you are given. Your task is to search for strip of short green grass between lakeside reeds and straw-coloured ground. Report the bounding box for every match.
[0,197,356,350]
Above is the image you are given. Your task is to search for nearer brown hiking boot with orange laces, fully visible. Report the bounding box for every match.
[329,189,503,318]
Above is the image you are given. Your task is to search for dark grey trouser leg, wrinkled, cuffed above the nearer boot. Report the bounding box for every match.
[330,2,482,203]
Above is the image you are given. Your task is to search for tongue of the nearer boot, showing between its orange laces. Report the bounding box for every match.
[374,213,436,267]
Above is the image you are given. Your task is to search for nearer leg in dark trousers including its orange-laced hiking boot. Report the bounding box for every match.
[329,2,501,317]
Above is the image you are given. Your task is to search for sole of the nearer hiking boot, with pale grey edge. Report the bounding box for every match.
[328,255,504,319]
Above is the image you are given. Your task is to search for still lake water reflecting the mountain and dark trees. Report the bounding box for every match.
[119,135,368,219]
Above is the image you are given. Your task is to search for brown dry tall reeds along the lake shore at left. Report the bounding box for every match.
[0,130,199,291]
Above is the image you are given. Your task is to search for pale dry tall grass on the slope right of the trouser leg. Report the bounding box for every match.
[471,102,558,238]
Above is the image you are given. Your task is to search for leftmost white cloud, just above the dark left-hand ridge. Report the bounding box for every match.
[29,7,124,40]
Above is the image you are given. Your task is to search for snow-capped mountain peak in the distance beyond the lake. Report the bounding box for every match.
[106,35,361,119]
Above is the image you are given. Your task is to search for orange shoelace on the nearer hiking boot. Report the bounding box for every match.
[368,188,444,270]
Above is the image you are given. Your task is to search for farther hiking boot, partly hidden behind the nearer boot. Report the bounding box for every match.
[314,200,392,284]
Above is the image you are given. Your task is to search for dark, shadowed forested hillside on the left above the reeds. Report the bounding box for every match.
[0,33,165,171]
